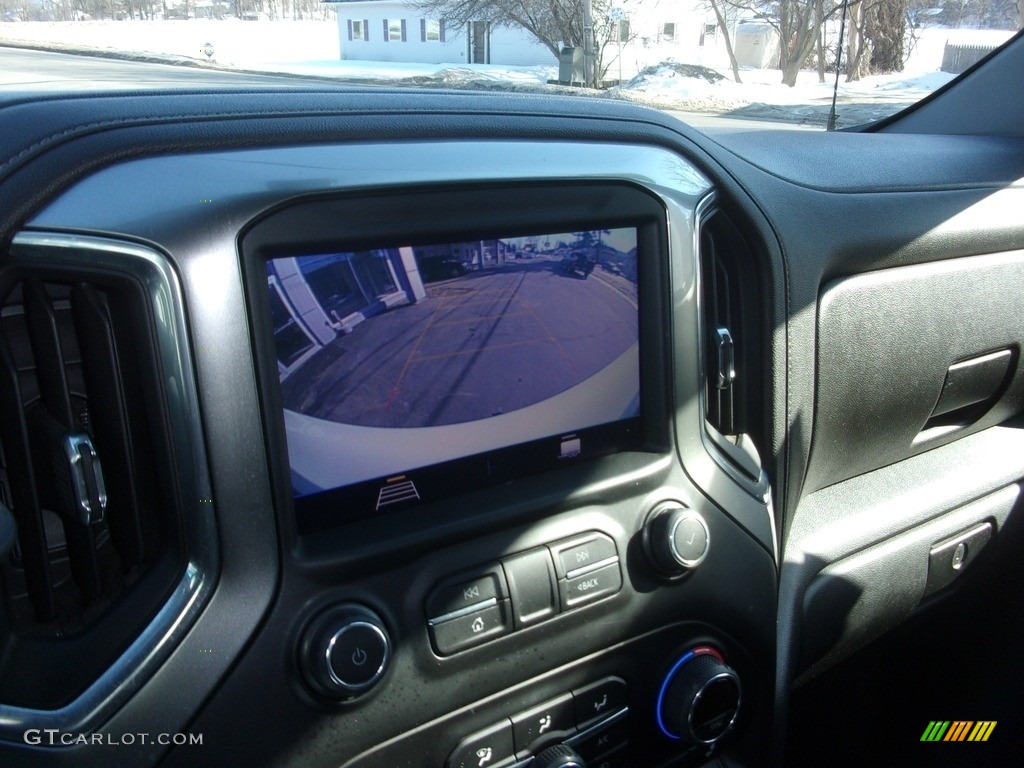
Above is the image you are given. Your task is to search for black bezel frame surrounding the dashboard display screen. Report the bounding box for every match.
[240,182,670,537]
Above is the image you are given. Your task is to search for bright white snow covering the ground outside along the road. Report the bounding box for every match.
[0,18,1014,124]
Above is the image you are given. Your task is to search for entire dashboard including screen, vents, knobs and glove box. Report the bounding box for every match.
[0,33,1024,768]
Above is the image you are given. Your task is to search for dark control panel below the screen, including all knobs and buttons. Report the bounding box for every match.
[280,494,773,768]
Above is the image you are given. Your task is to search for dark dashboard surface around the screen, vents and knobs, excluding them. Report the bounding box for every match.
[0,58,1024,767]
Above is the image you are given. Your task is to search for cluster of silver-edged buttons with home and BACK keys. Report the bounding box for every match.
[426,531,623,655]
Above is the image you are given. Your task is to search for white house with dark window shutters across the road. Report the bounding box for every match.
[325,0,728,78]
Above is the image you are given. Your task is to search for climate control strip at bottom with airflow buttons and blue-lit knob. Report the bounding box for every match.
[444,633,750,768]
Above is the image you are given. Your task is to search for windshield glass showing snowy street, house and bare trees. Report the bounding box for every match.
[0,0,1024,130]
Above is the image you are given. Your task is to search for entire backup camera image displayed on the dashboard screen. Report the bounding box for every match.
[266,227,640,524]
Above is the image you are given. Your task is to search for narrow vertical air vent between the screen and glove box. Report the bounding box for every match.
[699,204,766,479]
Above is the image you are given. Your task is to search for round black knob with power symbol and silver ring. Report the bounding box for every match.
[299,603,391,701]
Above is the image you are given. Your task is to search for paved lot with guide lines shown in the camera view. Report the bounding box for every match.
[282,258,637,427]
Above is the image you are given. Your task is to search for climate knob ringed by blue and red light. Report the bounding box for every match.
[655,646,741,746]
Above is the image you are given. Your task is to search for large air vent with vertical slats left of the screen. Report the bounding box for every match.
[0,238,211,719]
